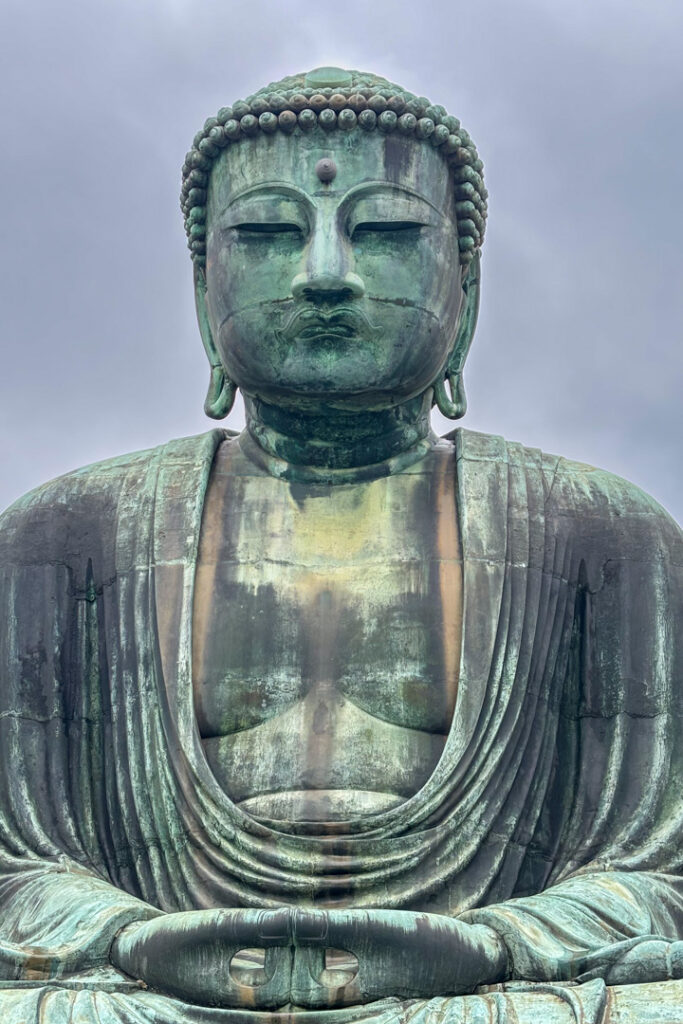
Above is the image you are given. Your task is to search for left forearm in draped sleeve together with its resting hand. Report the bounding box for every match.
[0,857,299,1008]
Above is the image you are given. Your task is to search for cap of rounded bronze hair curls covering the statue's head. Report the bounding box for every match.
[180,68,488,266]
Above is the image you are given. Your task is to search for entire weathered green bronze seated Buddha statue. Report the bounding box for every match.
[0,68,683,1024]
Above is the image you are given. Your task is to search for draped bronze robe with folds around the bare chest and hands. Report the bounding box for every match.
[0,430,683,1024]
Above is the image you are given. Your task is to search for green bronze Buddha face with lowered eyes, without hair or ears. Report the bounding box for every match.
[200,129,462,409]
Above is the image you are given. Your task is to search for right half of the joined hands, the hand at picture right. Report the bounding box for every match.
[291,910,507,1009]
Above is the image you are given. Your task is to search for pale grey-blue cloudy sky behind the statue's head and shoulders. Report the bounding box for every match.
[0,0,683,521]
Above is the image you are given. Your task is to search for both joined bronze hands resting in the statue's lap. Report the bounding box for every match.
[111,908,507,1009]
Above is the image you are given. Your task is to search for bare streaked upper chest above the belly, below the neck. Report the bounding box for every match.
[189,440,462,736]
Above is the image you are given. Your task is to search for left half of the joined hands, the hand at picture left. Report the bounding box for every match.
[110,908,294,1009]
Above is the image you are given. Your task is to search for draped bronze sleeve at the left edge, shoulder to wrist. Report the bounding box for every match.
[0,483,160,980]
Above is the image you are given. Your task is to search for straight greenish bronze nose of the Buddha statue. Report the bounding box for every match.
[291,205,366,302]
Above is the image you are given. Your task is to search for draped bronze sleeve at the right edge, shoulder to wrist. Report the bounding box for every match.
[465,471,683,984]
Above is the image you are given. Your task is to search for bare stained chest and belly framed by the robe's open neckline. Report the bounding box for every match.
[194,442,462,821]
